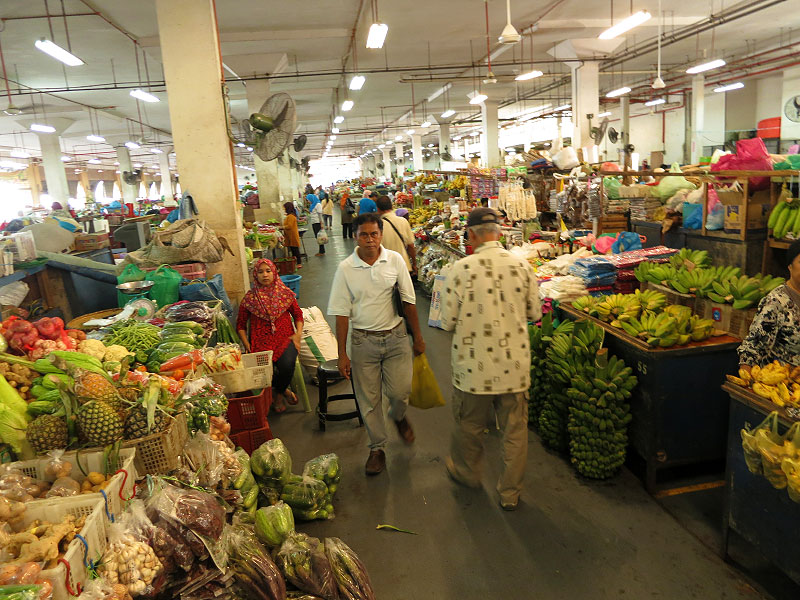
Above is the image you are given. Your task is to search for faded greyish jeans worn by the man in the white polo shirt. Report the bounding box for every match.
[350,321,413,450]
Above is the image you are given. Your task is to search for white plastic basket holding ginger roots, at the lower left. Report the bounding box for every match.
[24,494,108,600]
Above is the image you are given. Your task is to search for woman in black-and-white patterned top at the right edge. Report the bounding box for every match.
[739,240,800,369]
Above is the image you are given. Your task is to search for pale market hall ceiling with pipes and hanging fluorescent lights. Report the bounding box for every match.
[0,0,800,168]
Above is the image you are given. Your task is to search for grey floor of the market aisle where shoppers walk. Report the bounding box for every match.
[270,211,761,600]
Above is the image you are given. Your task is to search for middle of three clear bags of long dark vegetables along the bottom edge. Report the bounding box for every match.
[276,532,339,600]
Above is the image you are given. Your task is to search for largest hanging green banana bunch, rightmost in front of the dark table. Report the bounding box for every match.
[567,349,638,479]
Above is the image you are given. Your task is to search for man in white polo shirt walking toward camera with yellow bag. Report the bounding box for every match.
[328,213,425,475]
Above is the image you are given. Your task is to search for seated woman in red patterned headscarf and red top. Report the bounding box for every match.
[236,258,303,413]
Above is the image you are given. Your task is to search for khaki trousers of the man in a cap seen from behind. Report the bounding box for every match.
[450,388,528,504]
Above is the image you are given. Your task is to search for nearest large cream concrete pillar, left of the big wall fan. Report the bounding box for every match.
[156,0,250,303]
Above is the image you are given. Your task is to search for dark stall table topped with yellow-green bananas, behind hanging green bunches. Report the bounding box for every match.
[559,304,741,496]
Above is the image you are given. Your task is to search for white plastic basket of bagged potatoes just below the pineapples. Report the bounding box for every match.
[17,448,138,522]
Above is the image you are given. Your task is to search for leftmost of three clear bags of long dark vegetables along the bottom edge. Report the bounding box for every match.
[225,525,286,600]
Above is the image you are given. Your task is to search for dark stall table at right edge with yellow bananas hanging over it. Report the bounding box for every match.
[722,383,800,584]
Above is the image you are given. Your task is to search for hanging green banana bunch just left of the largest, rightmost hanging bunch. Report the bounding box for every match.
[539,321,604,452]
